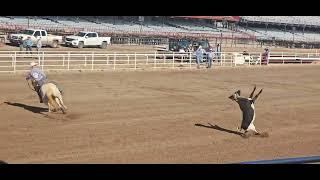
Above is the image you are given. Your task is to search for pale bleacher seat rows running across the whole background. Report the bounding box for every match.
[0,16,320,42]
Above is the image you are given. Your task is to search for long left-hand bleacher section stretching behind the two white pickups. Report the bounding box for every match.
[0,16,251,37]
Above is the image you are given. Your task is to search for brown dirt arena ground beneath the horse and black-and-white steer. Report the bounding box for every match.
[0,65,320,163]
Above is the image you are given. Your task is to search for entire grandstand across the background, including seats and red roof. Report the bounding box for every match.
[0,16,320,47]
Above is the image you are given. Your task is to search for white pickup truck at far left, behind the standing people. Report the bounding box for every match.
[9,29,63,48]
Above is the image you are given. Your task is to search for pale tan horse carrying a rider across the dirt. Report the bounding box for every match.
[41,83,67,114]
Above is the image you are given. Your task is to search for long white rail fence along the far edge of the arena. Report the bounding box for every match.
[0,51,320,72]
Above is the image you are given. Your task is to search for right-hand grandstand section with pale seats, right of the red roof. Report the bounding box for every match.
[239,16,320,47]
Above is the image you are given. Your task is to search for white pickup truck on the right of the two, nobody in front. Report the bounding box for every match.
[65,31,111,49]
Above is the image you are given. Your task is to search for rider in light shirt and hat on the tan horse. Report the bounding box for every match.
[26,62,47,103]
